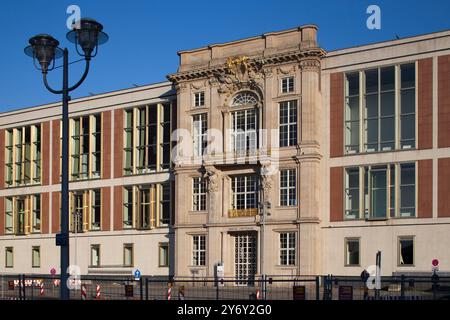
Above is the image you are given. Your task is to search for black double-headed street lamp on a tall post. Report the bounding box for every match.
[24,18,108,300]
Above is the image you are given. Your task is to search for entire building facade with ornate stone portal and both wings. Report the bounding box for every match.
[0,25,450,283]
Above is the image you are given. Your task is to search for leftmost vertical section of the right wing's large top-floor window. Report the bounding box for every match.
[345,72,360,153]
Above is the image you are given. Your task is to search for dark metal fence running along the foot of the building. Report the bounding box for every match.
[0,274,450,300]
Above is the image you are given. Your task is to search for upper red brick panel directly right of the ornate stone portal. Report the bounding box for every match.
[330,72,344,157]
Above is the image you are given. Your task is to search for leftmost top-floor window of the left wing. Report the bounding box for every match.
[5,125,41,187]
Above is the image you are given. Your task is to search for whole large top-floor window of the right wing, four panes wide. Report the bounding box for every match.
[344,63,416,154]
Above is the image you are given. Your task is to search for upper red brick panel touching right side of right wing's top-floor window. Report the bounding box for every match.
[417,58,433,149]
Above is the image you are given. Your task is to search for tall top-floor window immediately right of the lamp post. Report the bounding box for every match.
[70,114,102,180]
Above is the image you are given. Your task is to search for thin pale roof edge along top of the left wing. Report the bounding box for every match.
[0,81,175,117]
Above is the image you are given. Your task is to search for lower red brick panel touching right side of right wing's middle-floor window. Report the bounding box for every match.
[417,159,433,218]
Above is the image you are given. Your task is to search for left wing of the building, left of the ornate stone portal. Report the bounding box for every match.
[0,83,176,275]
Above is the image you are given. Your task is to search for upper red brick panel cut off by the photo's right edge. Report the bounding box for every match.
[438,55,450,148]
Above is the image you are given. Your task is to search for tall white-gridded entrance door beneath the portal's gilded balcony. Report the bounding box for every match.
[234,232,257,285]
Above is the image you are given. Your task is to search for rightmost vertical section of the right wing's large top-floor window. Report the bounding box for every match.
[400,63,416,149]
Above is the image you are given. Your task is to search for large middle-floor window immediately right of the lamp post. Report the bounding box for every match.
[69,189,102,233]
